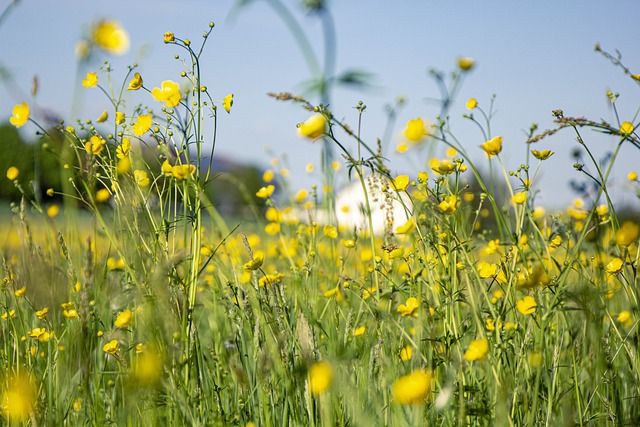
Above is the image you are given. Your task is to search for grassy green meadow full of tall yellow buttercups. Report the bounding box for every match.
[0,7,640,427]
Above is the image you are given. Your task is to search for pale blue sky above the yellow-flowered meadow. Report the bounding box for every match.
[0,0,640,210]
